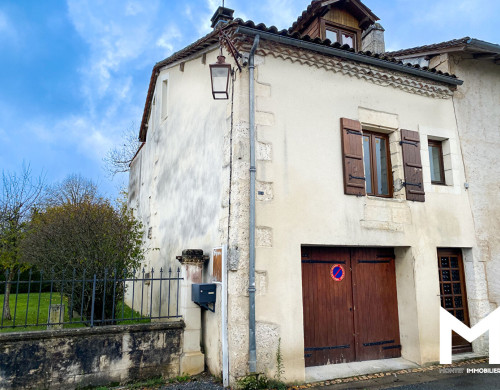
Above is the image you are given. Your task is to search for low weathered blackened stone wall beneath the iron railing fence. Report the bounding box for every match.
[0,321,184,390]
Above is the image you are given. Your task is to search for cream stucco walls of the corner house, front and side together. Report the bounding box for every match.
[129,38,498,383]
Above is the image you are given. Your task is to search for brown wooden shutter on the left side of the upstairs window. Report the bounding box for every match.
[340,118,366,196]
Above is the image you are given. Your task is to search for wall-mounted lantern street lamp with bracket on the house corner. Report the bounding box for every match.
[210,28,241,100]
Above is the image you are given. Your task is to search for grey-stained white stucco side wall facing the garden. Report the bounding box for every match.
[129,46,230,375]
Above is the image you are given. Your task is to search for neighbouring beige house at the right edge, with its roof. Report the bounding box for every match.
[389,37,500,320]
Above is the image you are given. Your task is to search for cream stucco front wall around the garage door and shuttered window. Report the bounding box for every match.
[224,50,475,381]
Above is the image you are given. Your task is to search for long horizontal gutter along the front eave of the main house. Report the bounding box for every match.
[236,26,464,86]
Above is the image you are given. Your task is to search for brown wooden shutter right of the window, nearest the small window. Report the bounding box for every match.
[400,130,425,202]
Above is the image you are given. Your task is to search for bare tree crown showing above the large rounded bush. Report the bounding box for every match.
[44,174,102,207]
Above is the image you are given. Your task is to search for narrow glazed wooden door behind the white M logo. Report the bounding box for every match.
[438,249,472,353]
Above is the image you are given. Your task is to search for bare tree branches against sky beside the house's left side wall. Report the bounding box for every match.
[103,124,142,177]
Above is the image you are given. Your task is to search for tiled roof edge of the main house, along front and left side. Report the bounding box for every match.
[139,19,462,142]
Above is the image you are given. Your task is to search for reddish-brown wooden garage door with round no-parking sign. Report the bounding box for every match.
[302,247,401,367]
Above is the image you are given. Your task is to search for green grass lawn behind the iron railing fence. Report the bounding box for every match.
[0,293,151,332]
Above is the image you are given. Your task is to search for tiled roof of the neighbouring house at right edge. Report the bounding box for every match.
[386,37,500,58]
